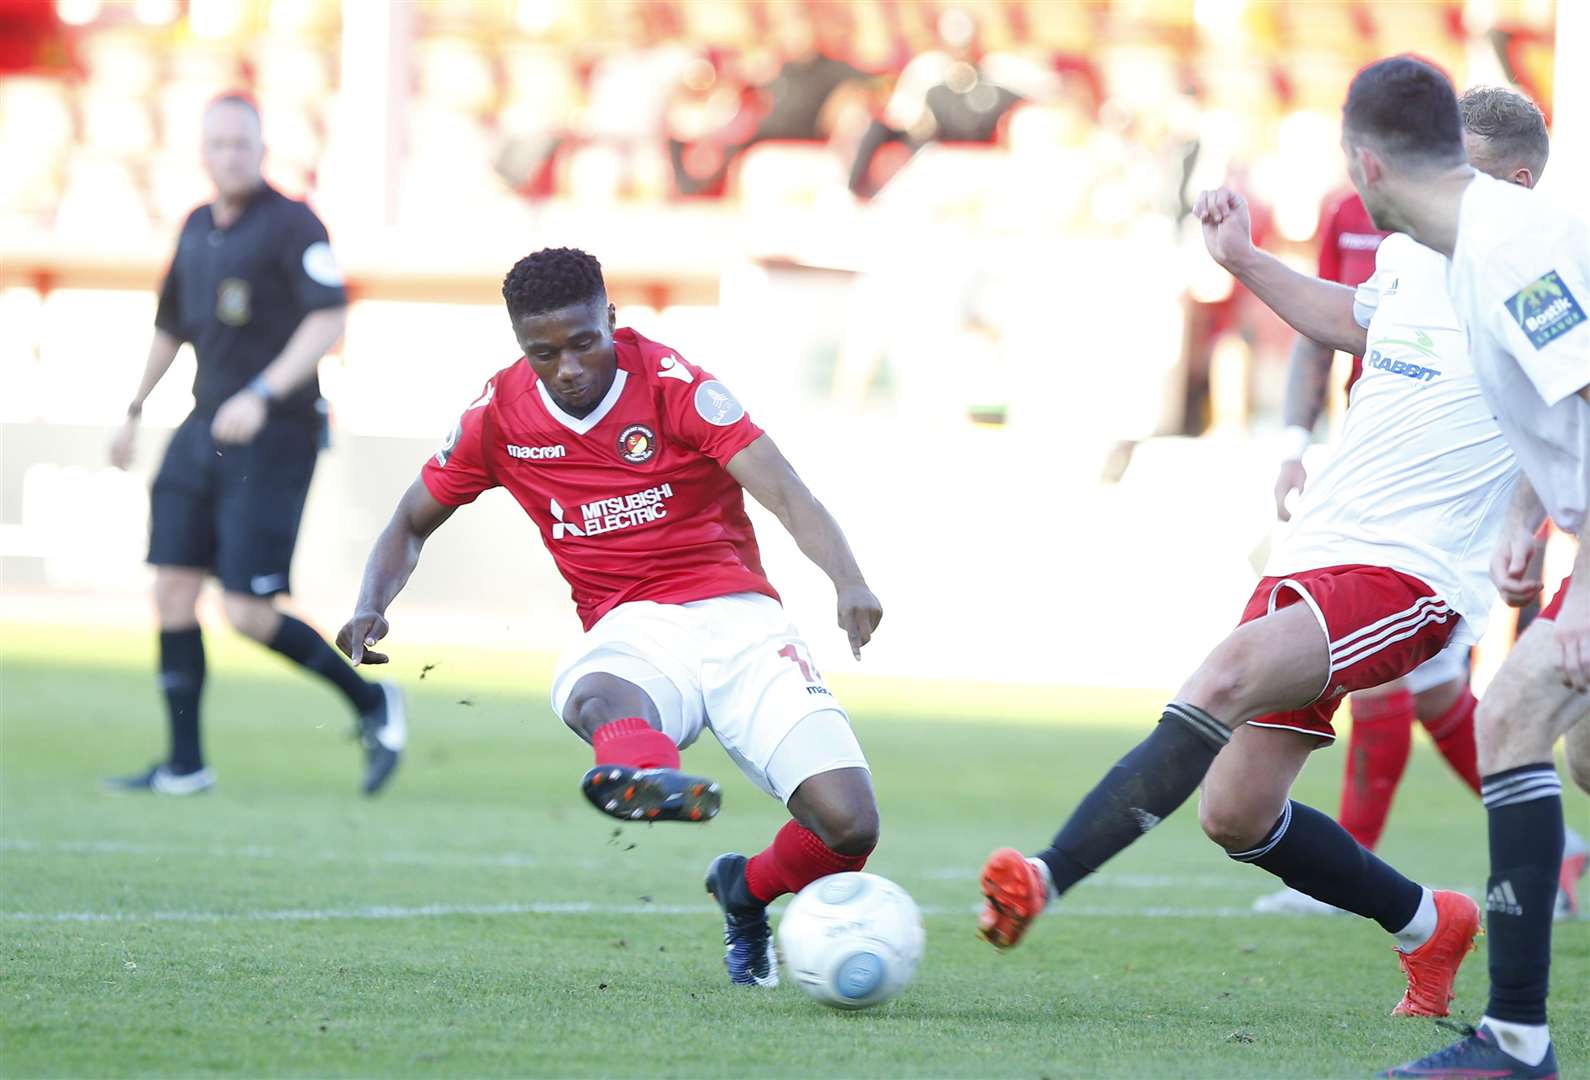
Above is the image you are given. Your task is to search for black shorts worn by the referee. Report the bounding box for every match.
[149,412,320,596]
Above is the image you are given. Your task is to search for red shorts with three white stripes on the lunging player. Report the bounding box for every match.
[1237,565,1458,740]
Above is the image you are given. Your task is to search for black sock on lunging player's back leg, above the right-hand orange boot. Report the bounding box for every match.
[1227,802,1425,934]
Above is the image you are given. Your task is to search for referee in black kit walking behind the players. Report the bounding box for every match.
[110,95,405,795]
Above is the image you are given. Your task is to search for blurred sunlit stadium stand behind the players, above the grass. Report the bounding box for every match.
[0,0,1590,693]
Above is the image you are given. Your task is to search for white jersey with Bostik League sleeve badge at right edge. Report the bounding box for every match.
[1448,177,1590,533]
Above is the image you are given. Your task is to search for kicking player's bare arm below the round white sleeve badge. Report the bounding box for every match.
[728,434,884,660]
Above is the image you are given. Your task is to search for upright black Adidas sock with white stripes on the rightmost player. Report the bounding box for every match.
[1480,762,1563,1024]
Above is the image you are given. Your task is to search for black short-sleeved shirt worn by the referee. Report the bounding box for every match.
[154,185,348,417]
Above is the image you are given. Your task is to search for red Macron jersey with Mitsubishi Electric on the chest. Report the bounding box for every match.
[420,329,778,630]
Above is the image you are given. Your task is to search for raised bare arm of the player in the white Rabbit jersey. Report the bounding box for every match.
[1193,188,1367,355]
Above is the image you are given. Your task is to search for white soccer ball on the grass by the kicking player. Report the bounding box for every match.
[779,873,922,1008]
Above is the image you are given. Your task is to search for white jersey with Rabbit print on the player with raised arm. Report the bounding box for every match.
[1264,234,1518,641]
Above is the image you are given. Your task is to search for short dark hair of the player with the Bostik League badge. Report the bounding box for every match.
[1342,56,1468,165]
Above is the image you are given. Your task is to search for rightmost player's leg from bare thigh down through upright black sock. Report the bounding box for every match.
[1450,620,1590,1066]
